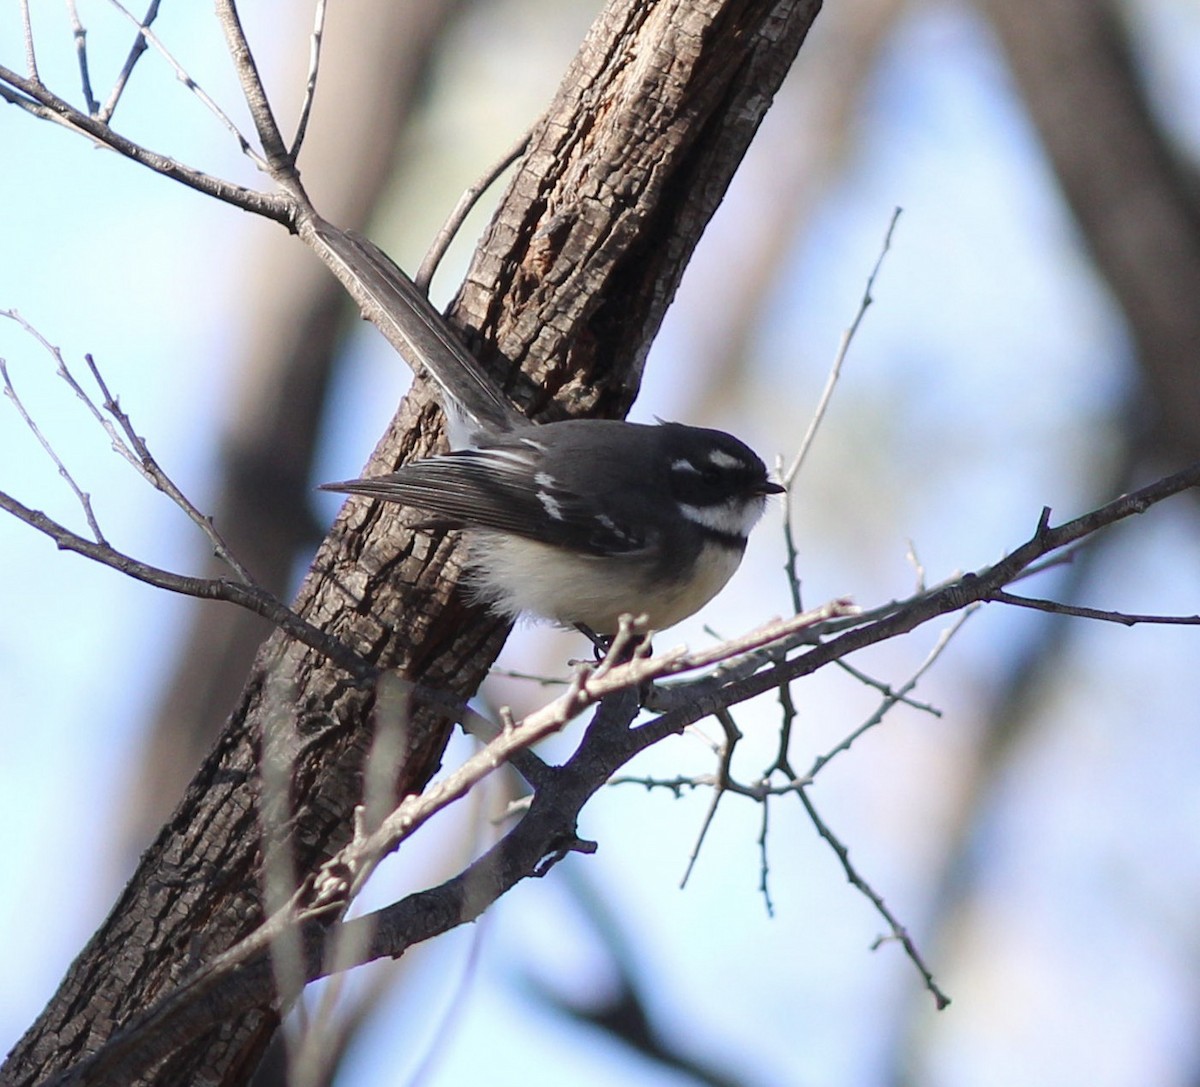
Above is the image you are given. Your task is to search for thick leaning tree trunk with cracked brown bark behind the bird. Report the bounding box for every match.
[0,0,820,1085]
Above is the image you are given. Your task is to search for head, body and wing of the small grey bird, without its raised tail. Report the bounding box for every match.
[322,419,784,636]
